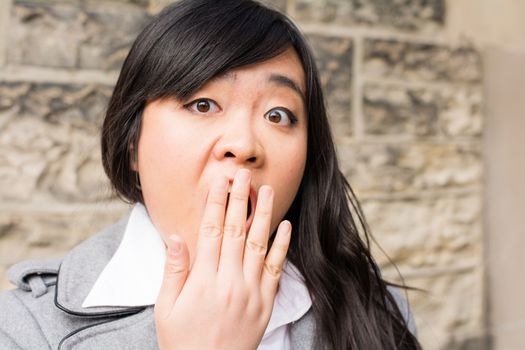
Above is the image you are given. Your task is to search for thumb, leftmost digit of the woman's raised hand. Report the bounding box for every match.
[155,235,189,318]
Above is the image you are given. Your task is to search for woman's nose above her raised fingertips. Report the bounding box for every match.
[214,117,264,167]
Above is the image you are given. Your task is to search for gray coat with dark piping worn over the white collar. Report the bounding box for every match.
[0,215,415,350]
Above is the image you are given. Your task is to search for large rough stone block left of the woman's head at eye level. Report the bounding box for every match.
[0,83,112,203]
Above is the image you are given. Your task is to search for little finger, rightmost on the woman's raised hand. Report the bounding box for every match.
[261,220,292,305]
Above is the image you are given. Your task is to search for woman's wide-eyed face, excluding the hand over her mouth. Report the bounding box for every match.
[133,49,307,261]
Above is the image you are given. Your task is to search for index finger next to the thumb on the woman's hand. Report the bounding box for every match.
[192,176,228,276]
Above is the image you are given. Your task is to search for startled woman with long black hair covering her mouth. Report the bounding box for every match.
[0,0,420,349]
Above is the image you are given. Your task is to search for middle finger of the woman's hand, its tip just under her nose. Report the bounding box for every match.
[218,169,251,276]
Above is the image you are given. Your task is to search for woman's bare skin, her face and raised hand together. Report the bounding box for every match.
[132,49,307,349]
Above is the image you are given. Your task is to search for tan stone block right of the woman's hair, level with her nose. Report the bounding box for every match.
[338,143,483,195]
